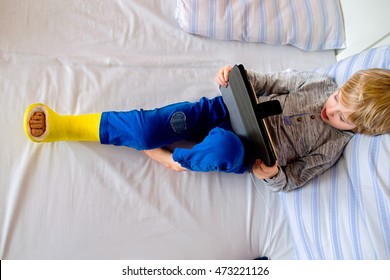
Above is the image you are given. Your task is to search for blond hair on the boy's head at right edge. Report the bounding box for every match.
[340,68,390,135]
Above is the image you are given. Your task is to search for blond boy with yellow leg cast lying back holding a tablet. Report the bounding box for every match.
[25,66,390,191]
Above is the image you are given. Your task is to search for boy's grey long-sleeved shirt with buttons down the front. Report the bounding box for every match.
[248,71,353,191]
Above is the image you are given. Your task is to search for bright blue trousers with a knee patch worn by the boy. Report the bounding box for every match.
[100,96,247,173]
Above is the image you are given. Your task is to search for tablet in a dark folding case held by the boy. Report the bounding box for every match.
[220,65,282,167]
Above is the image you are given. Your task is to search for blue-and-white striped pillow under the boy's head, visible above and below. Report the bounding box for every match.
[281,46,390,259]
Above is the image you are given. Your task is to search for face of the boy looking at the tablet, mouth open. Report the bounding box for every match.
[321,90,356,130]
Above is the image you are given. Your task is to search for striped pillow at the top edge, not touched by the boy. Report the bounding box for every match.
[176,0,345,50]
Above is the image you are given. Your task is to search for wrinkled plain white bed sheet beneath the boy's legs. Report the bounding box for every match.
[0,0,335,259]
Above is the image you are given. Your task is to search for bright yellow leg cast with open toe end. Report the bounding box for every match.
[24,103,102,142]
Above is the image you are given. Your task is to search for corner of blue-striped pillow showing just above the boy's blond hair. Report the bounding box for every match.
[316,45,390,86]
